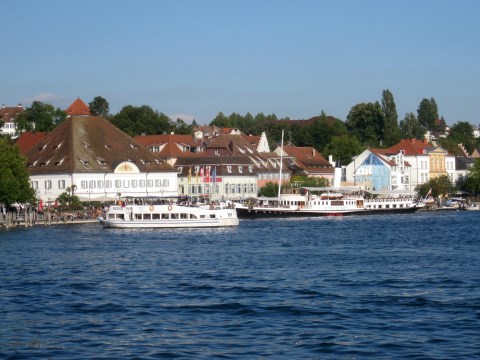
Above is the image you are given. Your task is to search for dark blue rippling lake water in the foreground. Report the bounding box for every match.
[0,211,480,359]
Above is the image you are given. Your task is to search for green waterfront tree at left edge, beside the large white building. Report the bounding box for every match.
[0,138,35,207]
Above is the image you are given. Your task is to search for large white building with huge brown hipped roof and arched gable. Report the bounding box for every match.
[25,116,178,203]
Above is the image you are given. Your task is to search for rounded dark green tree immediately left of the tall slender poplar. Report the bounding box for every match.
[346,101,383,147]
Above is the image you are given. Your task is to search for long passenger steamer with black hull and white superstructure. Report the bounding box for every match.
[236,187,424,218]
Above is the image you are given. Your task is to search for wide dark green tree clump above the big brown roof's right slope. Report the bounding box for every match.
[111,105,172,136]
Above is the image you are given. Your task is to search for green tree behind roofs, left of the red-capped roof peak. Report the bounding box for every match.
[16,101,67,135]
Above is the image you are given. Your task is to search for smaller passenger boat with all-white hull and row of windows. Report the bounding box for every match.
[98,197,239,228]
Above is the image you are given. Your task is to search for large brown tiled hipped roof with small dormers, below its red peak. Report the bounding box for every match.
[26,116,174,174]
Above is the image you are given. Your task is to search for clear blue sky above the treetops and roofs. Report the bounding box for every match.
[0,0,480,125]
